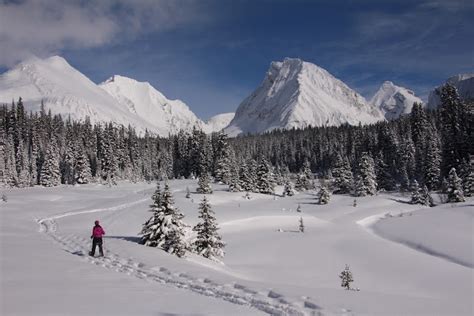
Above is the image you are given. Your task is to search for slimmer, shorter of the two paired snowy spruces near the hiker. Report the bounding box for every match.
[193,196,225,260]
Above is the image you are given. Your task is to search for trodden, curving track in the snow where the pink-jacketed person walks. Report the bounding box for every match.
[37,198,322,315]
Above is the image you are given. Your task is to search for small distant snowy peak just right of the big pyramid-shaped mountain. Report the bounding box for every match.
[370,81,423,120]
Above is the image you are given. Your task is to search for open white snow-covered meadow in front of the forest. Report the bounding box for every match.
[0,180,474,315]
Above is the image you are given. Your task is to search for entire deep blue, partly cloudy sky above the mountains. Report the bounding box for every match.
[0,0,474,119]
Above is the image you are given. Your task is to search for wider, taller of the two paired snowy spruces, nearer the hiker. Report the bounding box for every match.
[141,183,187,257]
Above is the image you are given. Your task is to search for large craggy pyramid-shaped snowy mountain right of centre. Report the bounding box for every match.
[225,58,384,136]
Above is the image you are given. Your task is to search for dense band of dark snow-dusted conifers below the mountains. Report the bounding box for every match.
[0,85,474,191]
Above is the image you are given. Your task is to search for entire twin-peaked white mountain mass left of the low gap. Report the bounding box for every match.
[0,56,205,136]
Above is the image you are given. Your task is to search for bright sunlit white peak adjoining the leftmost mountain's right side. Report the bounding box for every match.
[99,75,205,136]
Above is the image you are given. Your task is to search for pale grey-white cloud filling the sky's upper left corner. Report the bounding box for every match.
[0,0,205,66]
